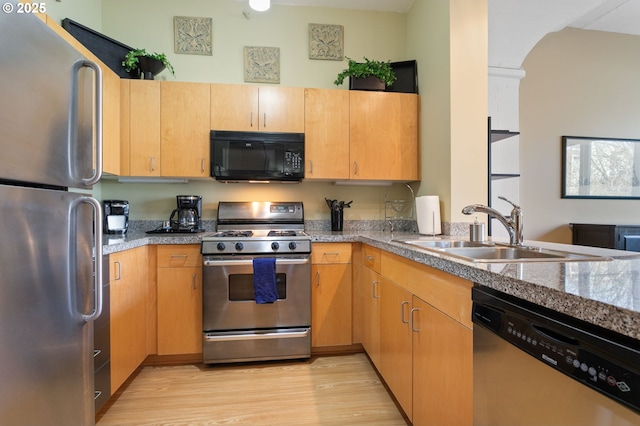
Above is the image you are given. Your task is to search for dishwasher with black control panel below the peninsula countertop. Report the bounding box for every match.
[472,285,640,426]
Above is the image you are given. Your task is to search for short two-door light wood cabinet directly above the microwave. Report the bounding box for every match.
[211,84,304,133]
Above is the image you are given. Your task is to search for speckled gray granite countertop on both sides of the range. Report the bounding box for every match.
[103,230,640,340]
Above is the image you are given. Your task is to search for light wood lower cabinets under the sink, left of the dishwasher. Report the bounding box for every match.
[358,245,473,426]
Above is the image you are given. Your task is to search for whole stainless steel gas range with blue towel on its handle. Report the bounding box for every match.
[202,202,311,364]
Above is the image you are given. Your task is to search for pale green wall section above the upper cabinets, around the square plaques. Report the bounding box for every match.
[102,0,410,88]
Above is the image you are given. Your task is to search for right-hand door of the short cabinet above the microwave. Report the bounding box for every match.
[258,86,304,133]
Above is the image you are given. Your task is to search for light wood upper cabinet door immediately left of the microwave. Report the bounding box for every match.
[160,81,211,177]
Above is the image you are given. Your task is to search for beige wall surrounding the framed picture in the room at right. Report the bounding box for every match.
[520,28,640,243]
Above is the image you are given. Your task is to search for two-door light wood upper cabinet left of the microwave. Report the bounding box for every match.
[120,79,211,178]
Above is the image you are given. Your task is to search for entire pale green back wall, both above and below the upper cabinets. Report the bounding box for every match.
[101,0,412,220]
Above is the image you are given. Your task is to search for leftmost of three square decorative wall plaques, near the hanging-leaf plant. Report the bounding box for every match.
[173,16,213,56]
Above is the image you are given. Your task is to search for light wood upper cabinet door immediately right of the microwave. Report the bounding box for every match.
[304,89,349,179]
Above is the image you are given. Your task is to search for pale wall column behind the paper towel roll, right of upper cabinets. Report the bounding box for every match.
[407,0,487,226]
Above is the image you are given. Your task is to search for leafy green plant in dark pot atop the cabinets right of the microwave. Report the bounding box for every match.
[333,56,396,90]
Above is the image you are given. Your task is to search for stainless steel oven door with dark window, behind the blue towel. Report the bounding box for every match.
[202,254,311,332]
